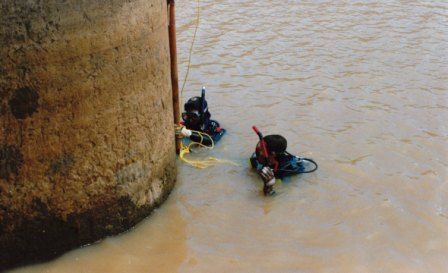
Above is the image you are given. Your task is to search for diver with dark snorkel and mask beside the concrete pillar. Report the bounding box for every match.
[176,87,226,146]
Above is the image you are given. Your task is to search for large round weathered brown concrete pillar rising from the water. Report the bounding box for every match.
[0,0,175,270]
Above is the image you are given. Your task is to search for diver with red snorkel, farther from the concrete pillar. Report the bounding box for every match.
[250,126,318,195]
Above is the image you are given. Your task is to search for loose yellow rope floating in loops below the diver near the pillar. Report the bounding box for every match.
[179,125,239,169]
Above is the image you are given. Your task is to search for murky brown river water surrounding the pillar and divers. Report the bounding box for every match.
[10,0,448,273]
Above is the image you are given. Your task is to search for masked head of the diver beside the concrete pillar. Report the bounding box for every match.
[182,97,210,130]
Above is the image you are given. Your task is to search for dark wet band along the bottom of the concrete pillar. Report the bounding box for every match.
[0,166,175,271]
